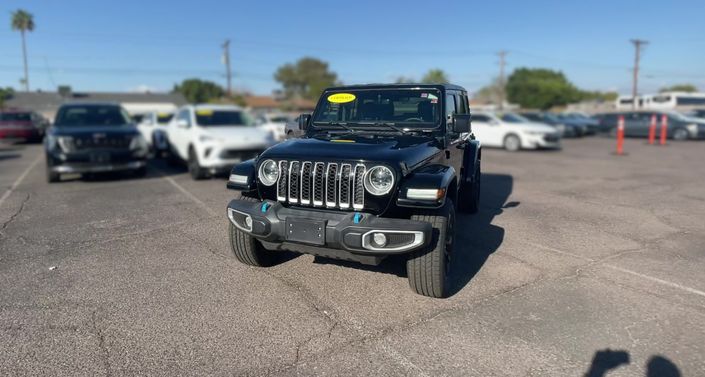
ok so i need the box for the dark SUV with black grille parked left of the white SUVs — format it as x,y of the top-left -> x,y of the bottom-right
44,103 -> 149,183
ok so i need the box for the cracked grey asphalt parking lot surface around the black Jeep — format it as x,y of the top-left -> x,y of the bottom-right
0,138 -> 705,376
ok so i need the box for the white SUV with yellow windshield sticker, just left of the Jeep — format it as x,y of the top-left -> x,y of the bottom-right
167,105 -> 274,179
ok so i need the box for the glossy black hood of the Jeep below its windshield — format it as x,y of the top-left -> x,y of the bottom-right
260,135 -> 441,169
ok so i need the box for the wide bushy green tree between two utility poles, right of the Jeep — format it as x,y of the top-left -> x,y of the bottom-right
506,68 -> 581,110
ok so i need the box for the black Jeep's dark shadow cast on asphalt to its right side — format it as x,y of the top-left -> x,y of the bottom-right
450,173 -> 520,296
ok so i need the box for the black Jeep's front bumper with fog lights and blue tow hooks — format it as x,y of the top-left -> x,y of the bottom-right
227,199 -> 432,259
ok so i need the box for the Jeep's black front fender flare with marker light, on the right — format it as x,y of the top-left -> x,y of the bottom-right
397,165 -> 456,208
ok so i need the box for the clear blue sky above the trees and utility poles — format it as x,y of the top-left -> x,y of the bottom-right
0,0 -> 705,94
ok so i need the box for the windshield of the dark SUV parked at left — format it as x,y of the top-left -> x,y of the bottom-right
54,105 -> 130,127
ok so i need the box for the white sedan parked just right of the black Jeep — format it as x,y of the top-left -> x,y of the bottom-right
472,112 -> 561,152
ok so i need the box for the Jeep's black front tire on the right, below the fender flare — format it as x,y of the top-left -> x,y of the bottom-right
406,198 -> 455,298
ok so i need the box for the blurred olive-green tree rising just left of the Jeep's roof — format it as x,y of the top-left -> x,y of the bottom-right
274,57 -> 338,101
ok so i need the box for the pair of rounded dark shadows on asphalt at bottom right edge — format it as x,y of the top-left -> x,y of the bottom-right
584,348 -> 681,377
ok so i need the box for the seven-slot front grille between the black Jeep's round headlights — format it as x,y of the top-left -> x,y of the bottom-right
277,161 -> 366,210
